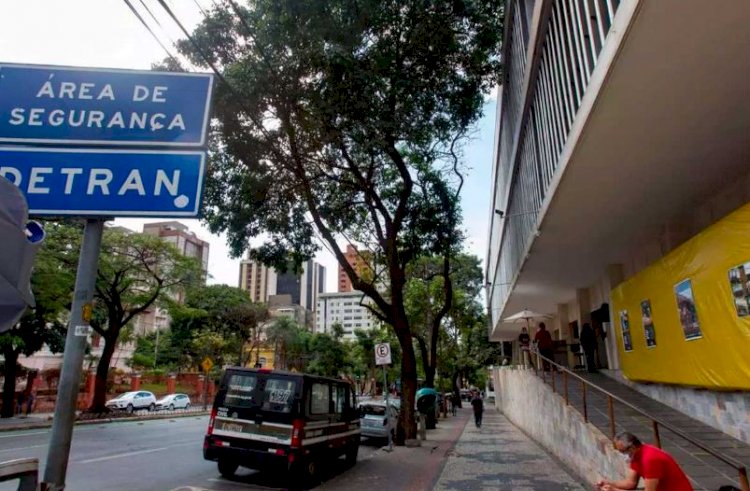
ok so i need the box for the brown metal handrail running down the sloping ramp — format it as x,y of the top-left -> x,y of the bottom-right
530,348 -> 750,491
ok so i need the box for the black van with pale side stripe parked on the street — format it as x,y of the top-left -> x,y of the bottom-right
203,368 -> 360,489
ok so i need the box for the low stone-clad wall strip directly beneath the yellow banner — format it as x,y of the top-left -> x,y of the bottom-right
602,370 -> 750,444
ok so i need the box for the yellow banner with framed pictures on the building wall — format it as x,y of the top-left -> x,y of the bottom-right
612,204 -> 750,389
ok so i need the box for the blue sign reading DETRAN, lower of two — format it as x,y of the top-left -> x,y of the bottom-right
0,147 -> 205,217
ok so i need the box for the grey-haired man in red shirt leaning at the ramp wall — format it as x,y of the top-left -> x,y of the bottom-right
596,431 -> 693,491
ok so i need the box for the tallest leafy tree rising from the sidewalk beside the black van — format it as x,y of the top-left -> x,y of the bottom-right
179,0 -> 503,442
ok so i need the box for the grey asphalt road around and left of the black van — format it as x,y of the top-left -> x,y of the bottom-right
0,416 -> 380,491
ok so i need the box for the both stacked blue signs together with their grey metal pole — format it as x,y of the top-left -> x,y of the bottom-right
27,64 -> 213,491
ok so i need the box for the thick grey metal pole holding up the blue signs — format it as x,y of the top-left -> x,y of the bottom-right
43,219 -> 104,491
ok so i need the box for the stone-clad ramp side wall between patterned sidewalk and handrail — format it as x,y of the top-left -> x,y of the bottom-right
493,367 -> 627,484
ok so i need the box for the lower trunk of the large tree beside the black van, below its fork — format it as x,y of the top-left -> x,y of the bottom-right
394,313 -> 417,445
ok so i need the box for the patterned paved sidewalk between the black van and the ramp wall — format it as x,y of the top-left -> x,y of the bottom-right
316,407 -> 585,491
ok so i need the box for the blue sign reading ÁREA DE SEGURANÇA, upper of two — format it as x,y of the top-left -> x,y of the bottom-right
0,64 -> 213,147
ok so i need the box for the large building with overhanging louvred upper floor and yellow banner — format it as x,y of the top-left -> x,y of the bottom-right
486,0 -> 750,441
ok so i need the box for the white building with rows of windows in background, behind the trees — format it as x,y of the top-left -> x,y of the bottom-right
315,290 -> 377,339
